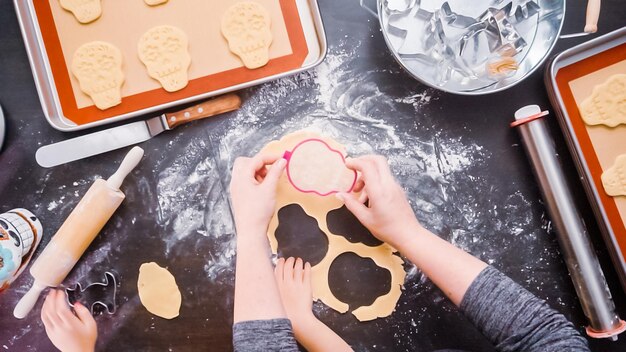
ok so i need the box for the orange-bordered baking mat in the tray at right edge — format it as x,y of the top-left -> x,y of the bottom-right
556,44 -> 626,258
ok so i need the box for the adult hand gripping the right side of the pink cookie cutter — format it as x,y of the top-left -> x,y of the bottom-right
337,155 -> 422,248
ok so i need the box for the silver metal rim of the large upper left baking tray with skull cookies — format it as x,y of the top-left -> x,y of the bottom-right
14,0 -> 327,132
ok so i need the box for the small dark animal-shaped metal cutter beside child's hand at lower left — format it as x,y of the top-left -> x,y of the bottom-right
65,271 -> 118,315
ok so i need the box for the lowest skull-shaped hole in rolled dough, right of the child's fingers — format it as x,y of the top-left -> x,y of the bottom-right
328,252 -> 391,310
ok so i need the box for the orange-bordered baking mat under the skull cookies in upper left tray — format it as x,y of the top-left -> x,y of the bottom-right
33,0 -> 308,125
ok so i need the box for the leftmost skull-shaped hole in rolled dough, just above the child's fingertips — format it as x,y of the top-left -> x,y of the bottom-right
276,204 -> 328,266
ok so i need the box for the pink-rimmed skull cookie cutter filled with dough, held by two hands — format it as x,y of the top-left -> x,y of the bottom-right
283,138 -> 358,197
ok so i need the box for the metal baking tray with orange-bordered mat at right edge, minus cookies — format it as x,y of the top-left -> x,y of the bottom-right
544,27 -> 626,292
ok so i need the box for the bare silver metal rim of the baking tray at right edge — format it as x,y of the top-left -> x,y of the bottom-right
545,27 -> 626,292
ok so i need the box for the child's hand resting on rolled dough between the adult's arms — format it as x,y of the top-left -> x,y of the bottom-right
274,258 -> 315,330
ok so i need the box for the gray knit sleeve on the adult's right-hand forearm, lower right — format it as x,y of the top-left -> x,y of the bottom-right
460,267 -> 589,352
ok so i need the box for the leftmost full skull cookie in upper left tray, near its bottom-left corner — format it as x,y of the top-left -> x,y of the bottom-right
71,41 -> 124,110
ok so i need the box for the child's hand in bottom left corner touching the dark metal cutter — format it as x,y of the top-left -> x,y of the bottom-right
41,289 -> 98,352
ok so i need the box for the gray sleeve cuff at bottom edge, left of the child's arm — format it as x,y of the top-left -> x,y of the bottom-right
233,319 -> 299,352
